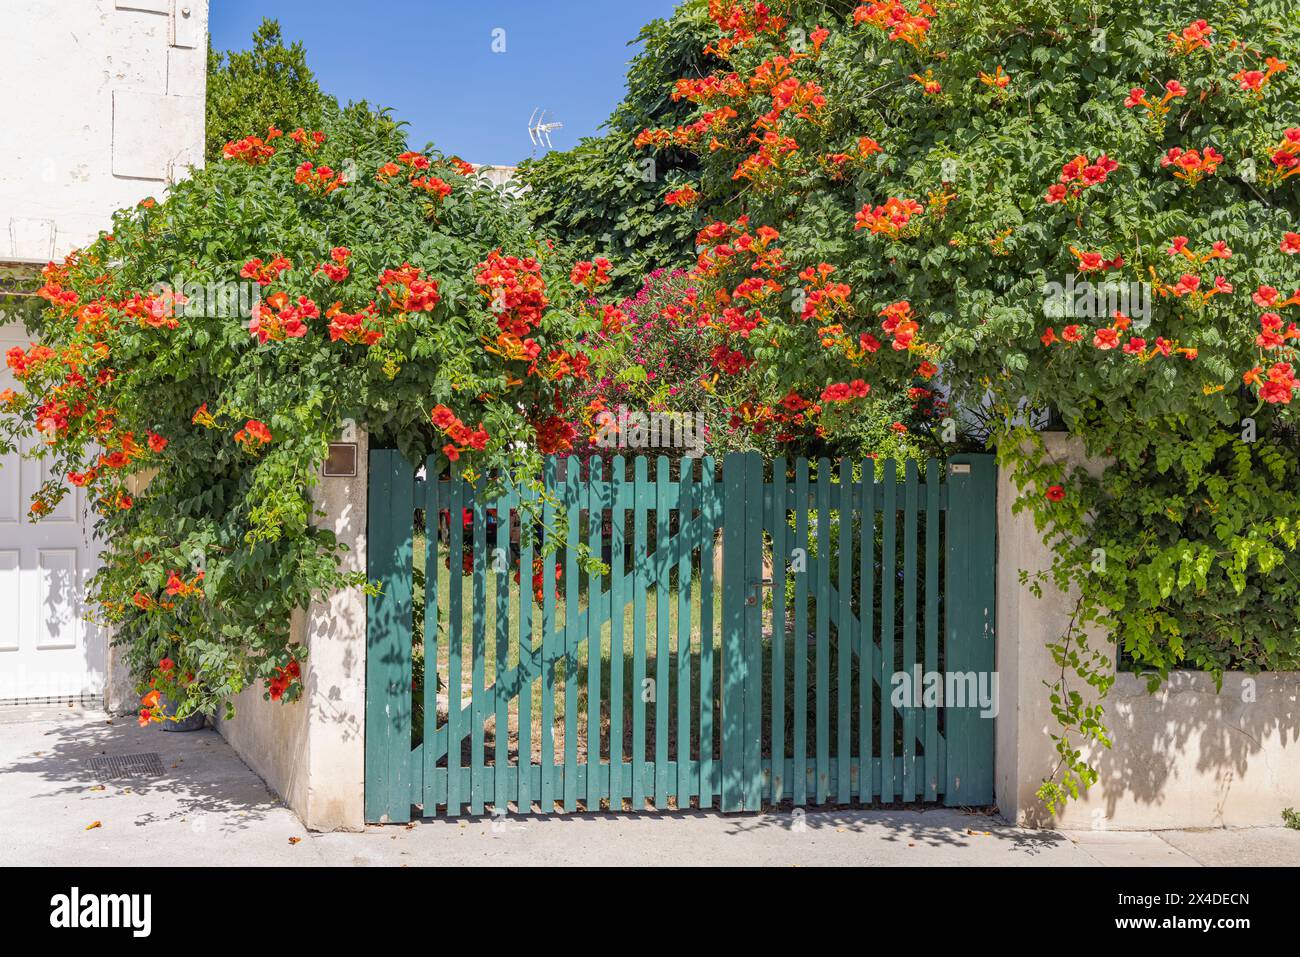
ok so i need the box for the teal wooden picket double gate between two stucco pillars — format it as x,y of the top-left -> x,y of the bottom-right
365,450 -> 996,822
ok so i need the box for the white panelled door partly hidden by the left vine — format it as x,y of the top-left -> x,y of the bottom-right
0,322 -> 105,702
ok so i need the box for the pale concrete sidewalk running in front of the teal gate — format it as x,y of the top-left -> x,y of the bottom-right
0,710 -> 1300,867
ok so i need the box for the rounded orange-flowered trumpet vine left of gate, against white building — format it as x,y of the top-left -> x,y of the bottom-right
0,108 -> 629,723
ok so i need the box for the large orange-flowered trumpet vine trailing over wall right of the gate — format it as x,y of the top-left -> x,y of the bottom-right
621,0 -> 1300,807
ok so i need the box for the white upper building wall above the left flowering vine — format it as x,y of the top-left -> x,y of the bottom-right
0,0 -> 208,263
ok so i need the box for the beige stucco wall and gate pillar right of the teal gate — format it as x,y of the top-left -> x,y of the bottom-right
996,434 -> 1300,830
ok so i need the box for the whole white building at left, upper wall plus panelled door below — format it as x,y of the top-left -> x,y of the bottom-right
0,0 -> 208,709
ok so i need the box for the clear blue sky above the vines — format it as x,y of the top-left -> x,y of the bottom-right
211,0 -> 676,165
